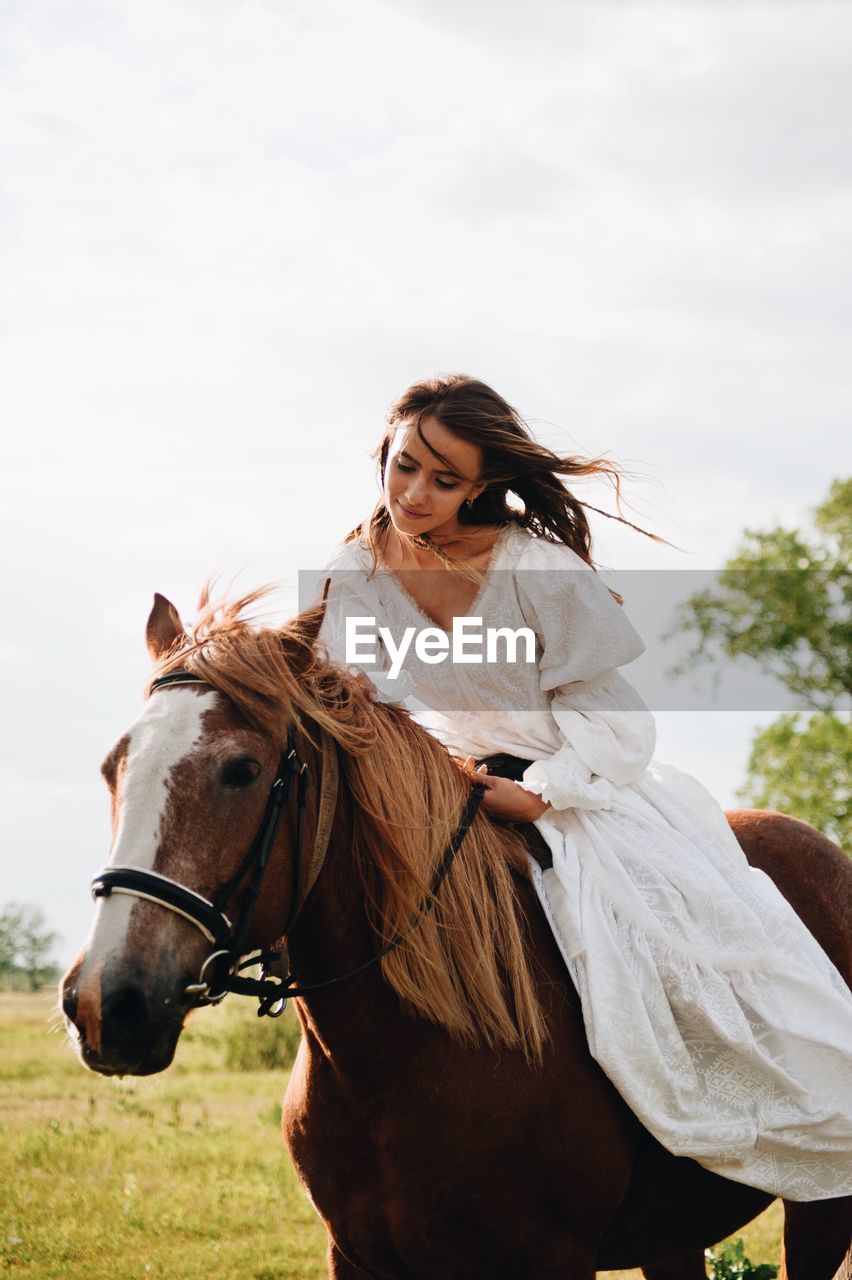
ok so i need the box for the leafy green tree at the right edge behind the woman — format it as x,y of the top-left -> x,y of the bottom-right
675,479 -> 852,847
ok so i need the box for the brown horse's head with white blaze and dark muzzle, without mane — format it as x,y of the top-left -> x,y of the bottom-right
61,595 -> 332,1075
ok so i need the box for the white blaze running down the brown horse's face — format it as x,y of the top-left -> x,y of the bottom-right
86,686 -> 216,972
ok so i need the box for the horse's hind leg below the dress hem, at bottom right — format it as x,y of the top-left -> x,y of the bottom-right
780,1196 -> 852,1280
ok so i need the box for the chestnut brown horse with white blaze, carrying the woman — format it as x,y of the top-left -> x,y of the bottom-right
63,596 -> 852,1280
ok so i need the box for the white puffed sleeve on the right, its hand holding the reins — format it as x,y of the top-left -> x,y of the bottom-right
517,539 -> 656,809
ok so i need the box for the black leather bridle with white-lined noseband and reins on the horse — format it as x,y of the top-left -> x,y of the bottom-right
92,669 -> 485,1018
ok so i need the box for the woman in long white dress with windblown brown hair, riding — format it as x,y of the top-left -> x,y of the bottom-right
313,375 -> 852,1201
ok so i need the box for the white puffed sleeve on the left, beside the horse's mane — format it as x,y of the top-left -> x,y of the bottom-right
316,543 -> 412,703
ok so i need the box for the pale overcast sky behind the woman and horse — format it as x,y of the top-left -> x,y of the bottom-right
0,0 -> 852,963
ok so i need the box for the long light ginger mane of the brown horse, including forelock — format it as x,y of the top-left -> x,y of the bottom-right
152,589 -> 546,1060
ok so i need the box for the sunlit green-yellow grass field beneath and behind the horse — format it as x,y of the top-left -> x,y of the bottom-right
0,992 -> 780,1280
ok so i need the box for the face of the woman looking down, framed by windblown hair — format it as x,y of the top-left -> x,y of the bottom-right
385,417 -> 485,538
